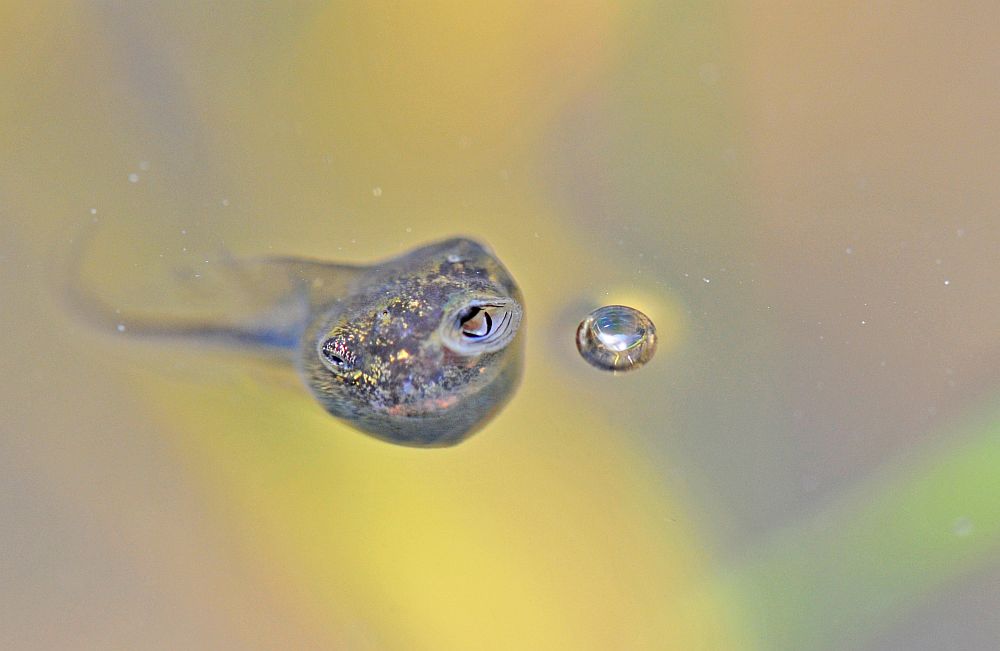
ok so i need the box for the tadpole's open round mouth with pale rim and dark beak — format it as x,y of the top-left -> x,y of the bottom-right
440,297 -> 522,355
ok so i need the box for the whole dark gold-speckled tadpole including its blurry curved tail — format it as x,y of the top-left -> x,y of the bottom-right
66,238 -> 524,447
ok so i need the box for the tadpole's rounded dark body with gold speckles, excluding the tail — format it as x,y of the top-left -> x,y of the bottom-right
297,239 -> 524,447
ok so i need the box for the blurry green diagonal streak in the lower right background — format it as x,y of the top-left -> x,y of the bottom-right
719,415 -> 1000,650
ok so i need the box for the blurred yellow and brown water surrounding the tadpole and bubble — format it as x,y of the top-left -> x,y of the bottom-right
0,3 -> 1000,649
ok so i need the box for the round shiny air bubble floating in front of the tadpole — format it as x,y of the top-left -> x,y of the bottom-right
576,305 -> 656,371
